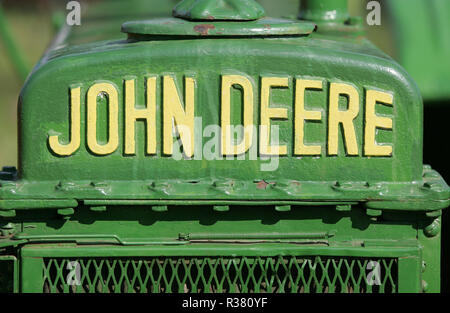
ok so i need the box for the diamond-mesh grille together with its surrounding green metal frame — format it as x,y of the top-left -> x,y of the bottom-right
19,245 -> 420,293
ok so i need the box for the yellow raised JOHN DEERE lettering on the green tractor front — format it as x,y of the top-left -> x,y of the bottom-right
48,75 -> 394,158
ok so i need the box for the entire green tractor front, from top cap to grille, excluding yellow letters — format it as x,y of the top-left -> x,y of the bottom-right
0,0 -> 450,292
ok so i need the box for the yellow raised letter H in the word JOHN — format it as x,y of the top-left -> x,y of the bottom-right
125,77 -> 156,155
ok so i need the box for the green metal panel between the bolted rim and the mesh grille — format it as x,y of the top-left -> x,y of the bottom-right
0,205 -> 439,292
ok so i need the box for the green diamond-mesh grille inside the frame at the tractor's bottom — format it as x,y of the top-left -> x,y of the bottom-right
43,256 -> 398,293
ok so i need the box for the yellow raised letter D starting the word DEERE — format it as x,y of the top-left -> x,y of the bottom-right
221,75 -> 254,155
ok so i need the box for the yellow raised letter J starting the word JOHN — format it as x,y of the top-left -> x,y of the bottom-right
48,87 -> 81,156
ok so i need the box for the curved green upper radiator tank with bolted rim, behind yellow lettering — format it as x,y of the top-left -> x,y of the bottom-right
5,23 -> 449,210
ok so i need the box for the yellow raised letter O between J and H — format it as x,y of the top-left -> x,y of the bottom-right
87,83 -> 119,155
